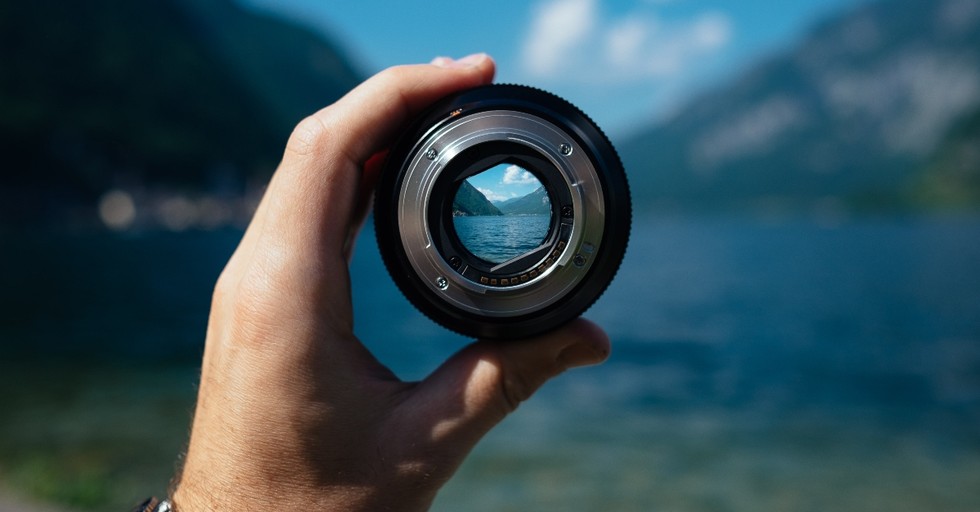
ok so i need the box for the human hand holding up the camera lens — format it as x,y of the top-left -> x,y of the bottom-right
173,55 -> 609,512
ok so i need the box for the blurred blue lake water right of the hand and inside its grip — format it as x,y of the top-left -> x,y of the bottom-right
354,218 -> 980,512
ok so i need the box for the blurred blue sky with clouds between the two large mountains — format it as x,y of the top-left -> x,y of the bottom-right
238,0 -> 868,139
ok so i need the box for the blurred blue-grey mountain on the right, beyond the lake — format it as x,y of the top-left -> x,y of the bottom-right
619,0 -> 980,210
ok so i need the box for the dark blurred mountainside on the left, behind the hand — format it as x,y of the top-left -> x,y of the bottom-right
0,0 -> 362,224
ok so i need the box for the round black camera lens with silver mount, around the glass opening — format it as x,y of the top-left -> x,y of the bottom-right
374,85 -> 631,339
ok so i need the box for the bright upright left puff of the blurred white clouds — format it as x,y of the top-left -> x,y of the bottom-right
524,0 -> 596,75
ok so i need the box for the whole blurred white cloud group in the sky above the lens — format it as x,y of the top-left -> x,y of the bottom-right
523,0 -> 733,84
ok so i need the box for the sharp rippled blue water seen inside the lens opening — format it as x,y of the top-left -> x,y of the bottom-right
453,215 -> 551,263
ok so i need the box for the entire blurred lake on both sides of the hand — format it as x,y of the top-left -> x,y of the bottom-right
0,216 -> 980,512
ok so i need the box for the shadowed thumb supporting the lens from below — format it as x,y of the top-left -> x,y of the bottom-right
417,318 -> 610,456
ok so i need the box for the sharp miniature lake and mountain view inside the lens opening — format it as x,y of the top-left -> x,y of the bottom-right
453,163 -> 551,263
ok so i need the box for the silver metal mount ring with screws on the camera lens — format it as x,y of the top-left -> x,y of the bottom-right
398,111 -> 605,317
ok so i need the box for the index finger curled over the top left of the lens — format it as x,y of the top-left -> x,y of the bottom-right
256,55 -> 494,264
